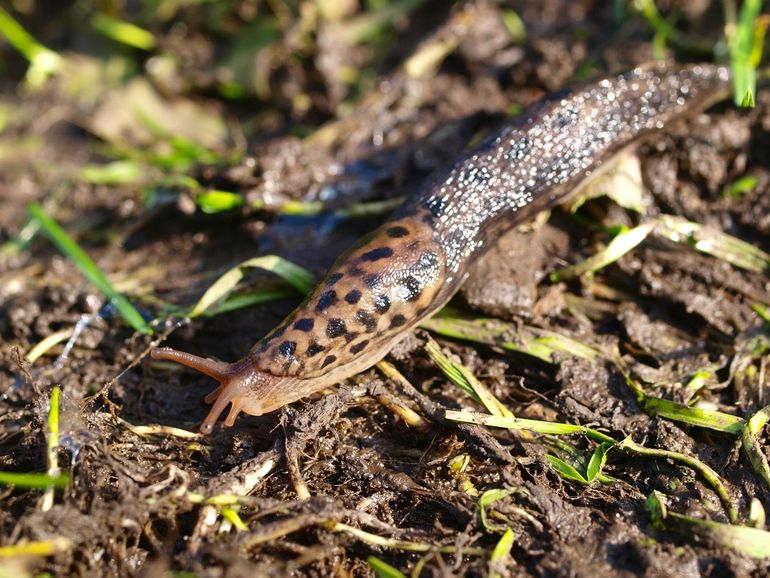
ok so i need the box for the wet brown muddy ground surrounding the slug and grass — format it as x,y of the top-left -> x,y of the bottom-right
0,0 -> 770,577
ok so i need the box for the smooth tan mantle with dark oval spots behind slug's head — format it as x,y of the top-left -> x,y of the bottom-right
249,218 -> 444,376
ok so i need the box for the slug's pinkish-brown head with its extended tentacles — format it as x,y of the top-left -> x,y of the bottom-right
150,347 -> 265,434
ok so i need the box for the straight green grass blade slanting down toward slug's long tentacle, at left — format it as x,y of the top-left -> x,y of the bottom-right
29,203 -> 152,335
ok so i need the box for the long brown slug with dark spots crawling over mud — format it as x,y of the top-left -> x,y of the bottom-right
152,63 -> 730,434
